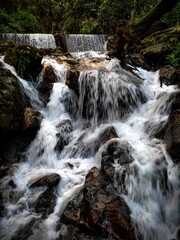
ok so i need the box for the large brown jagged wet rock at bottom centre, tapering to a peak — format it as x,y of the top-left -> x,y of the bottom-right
59,168 -> 135,240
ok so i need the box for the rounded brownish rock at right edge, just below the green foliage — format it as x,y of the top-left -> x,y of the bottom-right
159,65 -> 180,85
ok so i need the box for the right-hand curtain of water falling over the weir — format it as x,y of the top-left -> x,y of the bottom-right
65,34 -> 106,52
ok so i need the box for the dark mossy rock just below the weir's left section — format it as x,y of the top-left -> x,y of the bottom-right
4,45 -> 44,79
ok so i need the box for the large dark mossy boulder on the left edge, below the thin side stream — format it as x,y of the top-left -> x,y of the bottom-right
0,68 -> 24,131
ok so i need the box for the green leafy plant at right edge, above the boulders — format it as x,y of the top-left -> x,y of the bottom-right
166,37 -> 180,68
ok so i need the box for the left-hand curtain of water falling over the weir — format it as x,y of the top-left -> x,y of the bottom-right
0,33 -> 56,48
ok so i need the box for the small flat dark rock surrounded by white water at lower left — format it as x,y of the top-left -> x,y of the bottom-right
27,173 -> 61,188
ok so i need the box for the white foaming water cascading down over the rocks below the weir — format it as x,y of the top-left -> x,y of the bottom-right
0,51 -> 180,240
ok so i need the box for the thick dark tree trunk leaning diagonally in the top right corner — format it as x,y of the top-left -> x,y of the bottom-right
134,0 -> 178,37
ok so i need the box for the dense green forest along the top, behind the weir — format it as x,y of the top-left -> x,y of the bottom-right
0,0 -> 180,34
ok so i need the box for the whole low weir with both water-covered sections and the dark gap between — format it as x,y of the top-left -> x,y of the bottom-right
0,33 -> 107,52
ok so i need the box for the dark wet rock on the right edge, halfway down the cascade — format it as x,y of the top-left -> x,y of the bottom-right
164,109 -> 180,162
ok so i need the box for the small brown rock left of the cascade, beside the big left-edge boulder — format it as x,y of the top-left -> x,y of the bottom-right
23,107 -> 43,130
